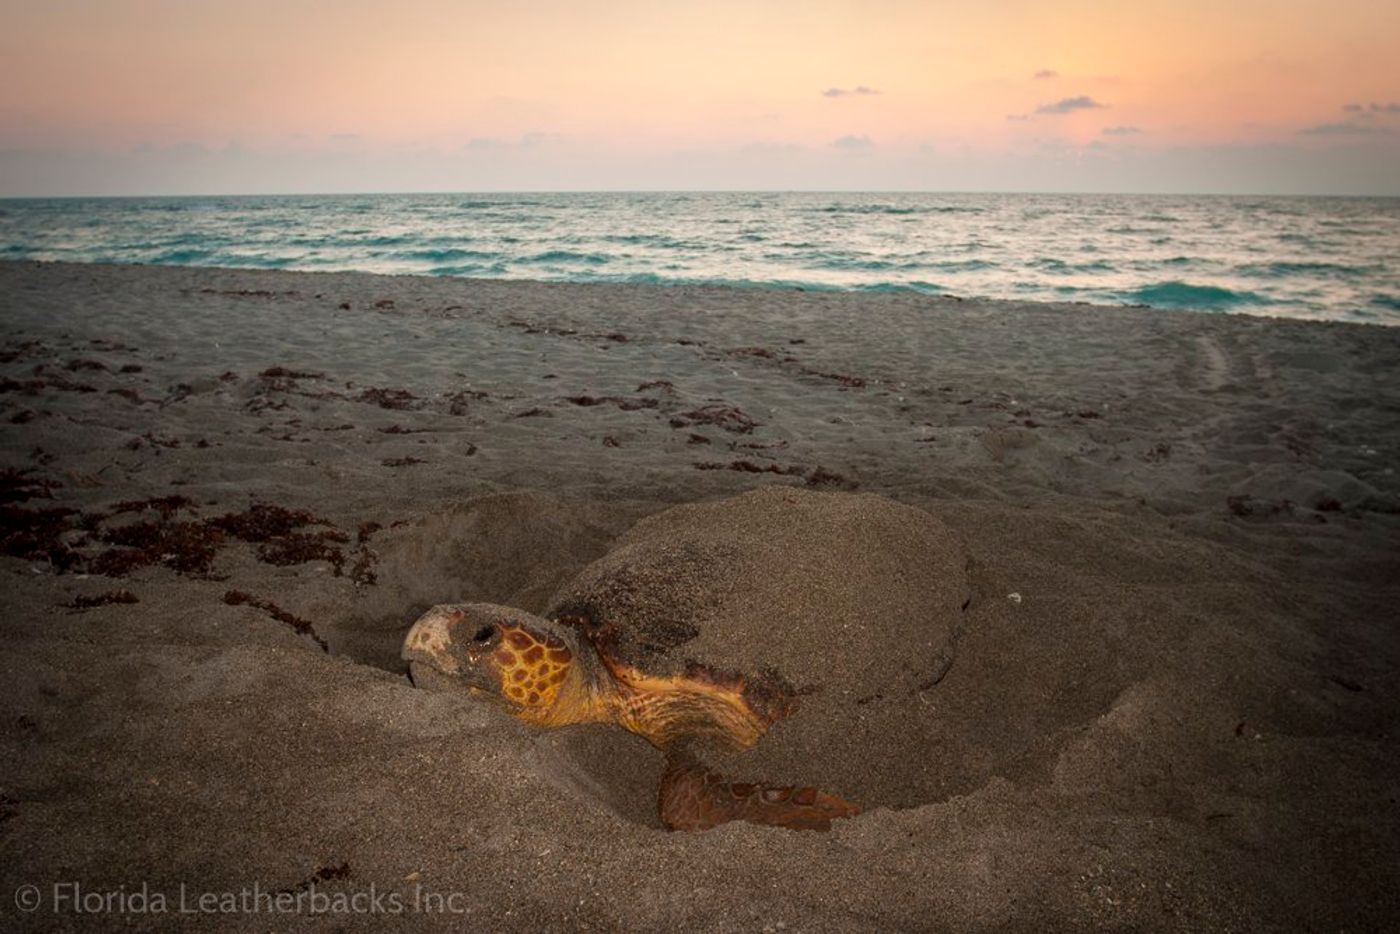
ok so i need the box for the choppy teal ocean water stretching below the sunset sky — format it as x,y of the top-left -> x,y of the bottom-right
0,192 -> 1400,325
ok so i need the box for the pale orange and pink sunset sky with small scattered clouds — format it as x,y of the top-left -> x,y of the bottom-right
0,0 -> 1400,196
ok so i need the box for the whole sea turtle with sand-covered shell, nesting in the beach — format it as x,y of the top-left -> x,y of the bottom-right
402,487 -> 966,830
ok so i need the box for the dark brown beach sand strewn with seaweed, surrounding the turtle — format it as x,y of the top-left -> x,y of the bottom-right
0,263 -> 1400,930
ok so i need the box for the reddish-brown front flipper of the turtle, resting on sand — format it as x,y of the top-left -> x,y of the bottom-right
657,752 -> 861,830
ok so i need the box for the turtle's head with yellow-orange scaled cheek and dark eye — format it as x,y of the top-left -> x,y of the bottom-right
402,604 -> 598,727
